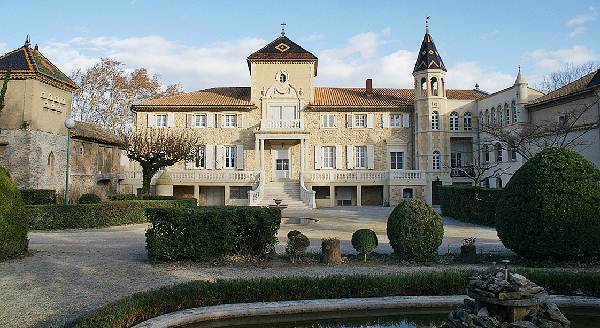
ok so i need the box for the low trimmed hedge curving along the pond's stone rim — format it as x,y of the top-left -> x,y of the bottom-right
63,269 -> 600,328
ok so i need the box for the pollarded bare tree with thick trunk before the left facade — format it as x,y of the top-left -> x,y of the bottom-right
124,129 -> 199,195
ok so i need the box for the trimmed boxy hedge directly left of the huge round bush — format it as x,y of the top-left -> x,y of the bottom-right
439,186 -> 503,227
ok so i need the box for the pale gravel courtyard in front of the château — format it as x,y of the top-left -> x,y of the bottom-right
0,207 -> 504,327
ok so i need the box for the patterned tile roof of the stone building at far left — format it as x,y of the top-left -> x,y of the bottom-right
0,45 -> 78,89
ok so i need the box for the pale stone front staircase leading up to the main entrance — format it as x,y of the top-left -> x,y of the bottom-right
257,180 -> 311,211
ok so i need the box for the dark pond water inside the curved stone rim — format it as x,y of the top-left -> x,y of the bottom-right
187,308 -> 600,328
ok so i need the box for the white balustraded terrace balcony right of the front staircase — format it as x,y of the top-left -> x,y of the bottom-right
304,170 -> 426,185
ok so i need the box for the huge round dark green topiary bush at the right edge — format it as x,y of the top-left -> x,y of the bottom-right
496,148 -> 600,259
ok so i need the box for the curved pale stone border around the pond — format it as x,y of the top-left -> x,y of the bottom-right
133,295 -> 600,328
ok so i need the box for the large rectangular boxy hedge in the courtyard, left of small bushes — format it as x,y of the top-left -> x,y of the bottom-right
146,206 -> 281,261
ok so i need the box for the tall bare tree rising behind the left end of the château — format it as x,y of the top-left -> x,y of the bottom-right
71,58 -> 181,134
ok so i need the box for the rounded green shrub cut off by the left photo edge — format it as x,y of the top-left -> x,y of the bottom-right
0,166 -> 29,261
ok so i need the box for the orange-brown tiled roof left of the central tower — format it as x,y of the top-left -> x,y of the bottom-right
133,87 -> 252,109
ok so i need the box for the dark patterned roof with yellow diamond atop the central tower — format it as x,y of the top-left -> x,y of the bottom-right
248,35 -> 317,61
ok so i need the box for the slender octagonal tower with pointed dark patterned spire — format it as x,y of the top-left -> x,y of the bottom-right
413,17 -> 451,203
